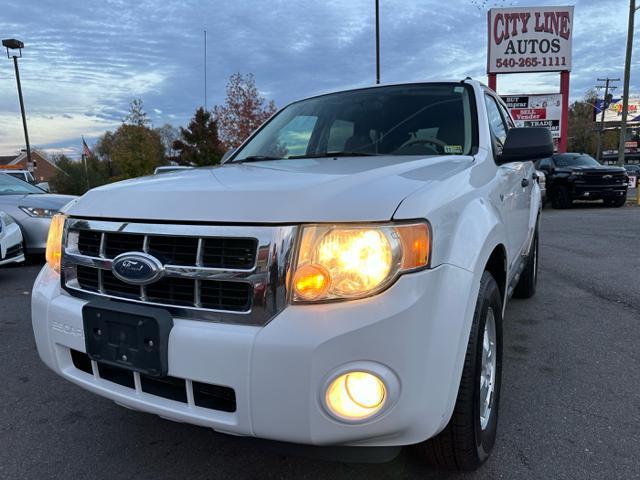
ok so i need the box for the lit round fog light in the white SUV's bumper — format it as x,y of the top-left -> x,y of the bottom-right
326,372 -> 387,420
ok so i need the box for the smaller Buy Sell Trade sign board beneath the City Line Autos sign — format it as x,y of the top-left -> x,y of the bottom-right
502,93 -> 562,138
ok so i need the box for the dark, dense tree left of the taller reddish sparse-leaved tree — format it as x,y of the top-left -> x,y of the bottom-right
173,107 -> 224,166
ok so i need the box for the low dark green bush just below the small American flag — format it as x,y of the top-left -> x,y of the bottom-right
51,155 -> 109,195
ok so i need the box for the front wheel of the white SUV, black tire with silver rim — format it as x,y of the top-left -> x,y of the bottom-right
415,271 -> 502,471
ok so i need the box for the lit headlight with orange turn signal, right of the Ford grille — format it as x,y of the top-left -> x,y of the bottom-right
291,223 -> 431,302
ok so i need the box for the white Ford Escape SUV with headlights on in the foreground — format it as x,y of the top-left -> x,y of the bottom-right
32,80 -> 553,469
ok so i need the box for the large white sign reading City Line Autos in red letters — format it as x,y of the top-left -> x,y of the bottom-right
487,7 -> 573,73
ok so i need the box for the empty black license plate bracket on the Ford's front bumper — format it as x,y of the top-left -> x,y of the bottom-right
82,300 -> 173,377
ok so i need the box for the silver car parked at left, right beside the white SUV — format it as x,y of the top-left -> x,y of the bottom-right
0,173 -> 76,255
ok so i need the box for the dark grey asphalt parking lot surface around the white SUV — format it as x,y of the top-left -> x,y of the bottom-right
0,206 -> 640,479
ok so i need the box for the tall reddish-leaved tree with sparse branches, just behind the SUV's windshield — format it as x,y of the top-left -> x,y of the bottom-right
214,73 -> 276,149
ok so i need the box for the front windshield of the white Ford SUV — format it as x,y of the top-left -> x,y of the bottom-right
233,83 -> 477,161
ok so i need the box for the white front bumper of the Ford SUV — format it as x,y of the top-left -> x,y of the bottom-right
32,265 -> 477,446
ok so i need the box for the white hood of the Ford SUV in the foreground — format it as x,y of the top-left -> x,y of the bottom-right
67,156 -> 473,223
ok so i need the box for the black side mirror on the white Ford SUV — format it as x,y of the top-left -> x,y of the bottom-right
498,127 -> 553,164
